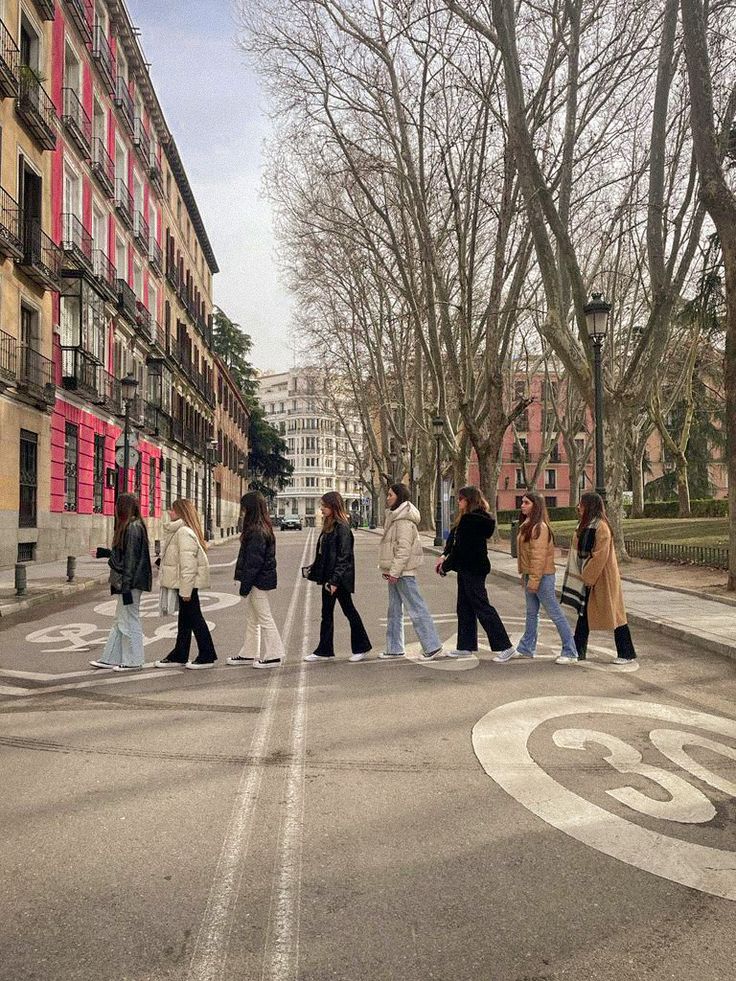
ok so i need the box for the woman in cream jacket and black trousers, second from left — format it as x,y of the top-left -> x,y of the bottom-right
155,498 -> 217,669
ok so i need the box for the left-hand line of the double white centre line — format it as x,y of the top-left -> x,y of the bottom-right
187,532 -> 312,981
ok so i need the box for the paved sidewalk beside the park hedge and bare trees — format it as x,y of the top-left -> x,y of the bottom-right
376,529 -> 736,659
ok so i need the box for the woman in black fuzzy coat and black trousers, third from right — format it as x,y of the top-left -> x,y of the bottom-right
436,487 -> 515,659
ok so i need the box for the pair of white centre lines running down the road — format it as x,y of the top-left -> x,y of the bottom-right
187,531 -> 314,981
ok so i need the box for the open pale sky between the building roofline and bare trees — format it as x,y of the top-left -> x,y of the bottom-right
127,0 -> 292,370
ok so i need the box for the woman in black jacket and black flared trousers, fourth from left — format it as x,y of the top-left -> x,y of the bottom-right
304,491 -> 371,661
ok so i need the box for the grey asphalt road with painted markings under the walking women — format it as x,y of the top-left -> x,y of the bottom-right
0,531 -> 736,981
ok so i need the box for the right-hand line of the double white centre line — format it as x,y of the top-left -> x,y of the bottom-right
261,568 -> 313,981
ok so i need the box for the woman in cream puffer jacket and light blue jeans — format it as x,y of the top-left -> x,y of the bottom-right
378,484 -> 442,660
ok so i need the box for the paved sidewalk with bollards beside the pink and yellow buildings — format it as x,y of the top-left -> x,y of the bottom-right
0,538 -> 235,622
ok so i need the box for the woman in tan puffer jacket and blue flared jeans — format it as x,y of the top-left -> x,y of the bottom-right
493,491 -> 578,664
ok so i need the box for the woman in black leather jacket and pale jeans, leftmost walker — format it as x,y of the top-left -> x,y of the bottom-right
90,494 -> 152,671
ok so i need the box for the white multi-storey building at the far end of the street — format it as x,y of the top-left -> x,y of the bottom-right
258,370 -> 366,527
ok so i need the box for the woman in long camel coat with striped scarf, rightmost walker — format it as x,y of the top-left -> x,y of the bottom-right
557,491 -> 636,664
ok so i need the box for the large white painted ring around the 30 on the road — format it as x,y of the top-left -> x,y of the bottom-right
472,695 -> 736,900
